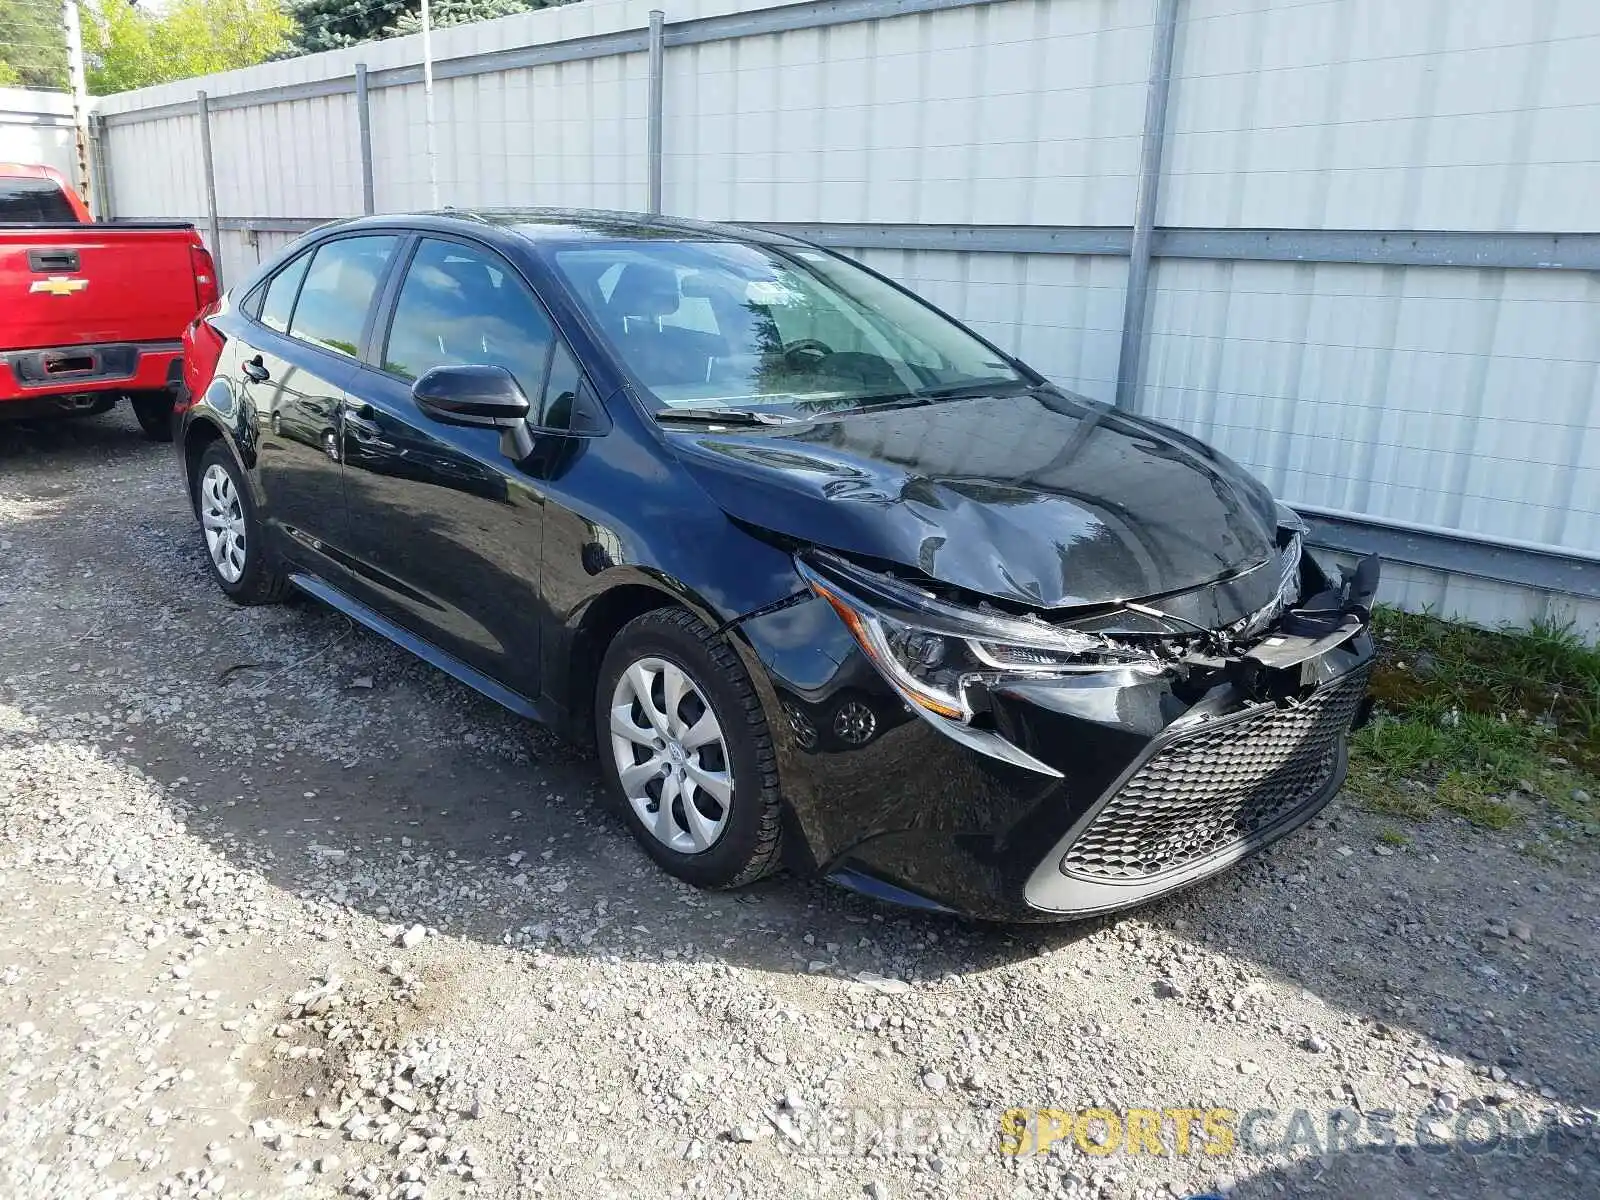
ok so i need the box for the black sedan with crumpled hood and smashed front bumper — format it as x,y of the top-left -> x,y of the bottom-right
174,211 -> 1378,920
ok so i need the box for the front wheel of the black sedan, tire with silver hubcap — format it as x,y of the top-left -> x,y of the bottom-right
594,608 -> 781,888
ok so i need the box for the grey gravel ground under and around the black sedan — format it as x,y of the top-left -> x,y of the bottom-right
0,413 -> 1600,1200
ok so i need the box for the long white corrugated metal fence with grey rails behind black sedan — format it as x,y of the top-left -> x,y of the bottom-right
84,0 -> 1600,637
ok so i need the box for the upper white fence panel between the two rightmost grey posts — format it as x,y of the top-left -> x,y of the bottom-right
664,0 -> 1150,224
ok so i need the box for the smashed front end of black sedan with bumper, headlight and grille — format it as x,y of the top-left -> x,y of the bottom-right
755,510 -> 1378,918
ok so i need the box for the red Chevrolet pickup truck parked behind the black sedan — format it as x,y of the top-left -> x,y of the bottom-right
0,163 -> 218,442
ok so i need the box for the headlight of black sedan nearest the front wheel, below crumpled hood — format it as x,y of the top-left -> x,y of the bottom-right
795,554 -> 1166,723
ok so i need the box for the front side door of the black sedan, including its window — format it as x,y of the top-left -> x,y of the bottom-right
341,237 -> 554,701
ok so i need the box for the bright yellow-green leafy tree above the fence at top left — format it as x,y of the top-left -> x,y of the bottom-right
83,0 -> 294,96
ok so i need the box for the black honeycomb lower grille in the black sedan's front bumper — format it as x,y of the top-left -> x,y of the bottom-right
1061,670 -> 1366,880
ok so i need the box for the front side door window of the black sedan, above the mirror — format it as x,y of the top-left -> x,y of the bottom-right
384,238 -> 554,400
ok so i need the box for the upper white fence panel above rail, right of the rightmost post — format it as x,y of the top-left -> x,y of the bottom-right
1157,0 -> 1600,232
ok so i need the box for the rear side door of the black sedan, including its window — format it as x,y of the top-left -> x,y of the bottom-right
232,234 -> 400,576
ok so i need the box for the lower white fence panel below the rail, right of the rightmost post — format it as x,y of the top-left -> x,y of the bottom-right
1141,259 -> 1600,550
